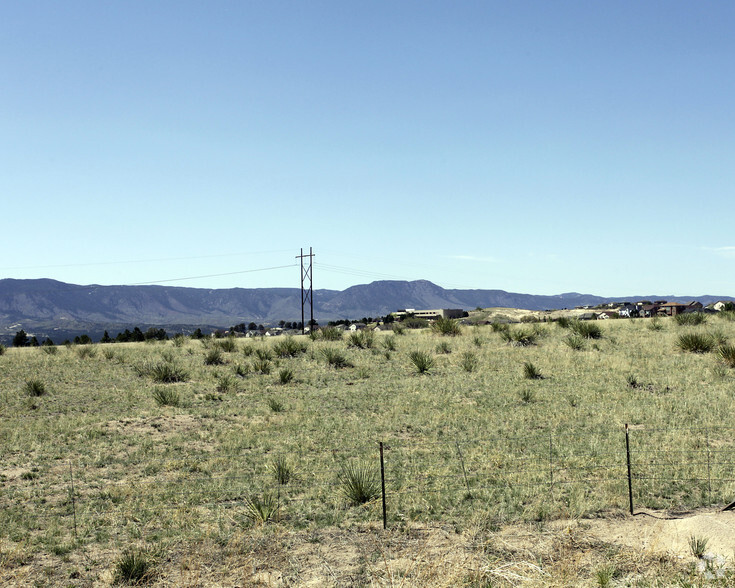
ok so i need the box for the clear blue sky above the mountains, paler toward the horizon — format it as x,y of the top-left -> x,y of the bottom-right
0,0 -> 735,296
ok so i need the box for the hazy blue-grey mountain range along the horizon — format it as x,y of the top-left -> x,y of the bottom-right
0,279 -> 733,343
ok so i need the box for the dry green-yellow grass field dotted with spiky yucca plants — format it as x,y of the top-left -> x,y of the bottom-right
0,309 -> 735,587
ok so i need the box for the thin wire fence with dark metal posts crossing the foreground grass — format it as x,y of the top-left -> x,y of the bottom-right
0,425 -> 735,539
